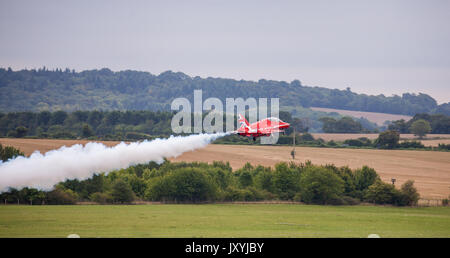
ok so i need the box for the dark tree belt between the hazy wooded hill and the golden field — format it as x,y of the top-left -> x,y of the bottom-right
0,111 -> 450,150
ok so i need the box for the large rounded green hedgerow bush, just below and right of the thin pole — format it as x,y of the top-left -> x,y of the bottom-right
300,167 -> 344,204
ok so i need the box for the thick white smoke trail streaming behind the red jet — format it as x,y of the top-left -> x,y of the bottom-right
0,133 -> 227,193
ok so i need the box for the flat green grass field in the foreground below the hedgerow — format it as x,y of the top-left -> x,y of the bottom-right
0,204 -> 450,238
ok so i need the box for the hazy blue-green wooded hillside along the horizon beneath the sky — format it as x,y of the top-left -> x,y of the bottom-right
0,67 -> 450,115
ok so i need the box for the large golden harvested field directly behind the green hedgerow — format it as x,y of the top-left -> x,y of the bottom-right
0,138 -> 450,199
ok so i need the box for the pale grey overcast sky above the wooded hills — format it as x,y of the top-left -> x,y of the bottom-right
0,0 -> 450,103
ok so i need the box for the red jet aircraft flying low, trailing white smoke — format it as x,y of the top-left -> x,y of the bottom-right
236,114 -> 290,141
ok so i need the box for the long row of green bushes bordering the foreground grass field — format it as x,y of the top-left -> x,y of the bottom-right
0,158 -> 420,206
